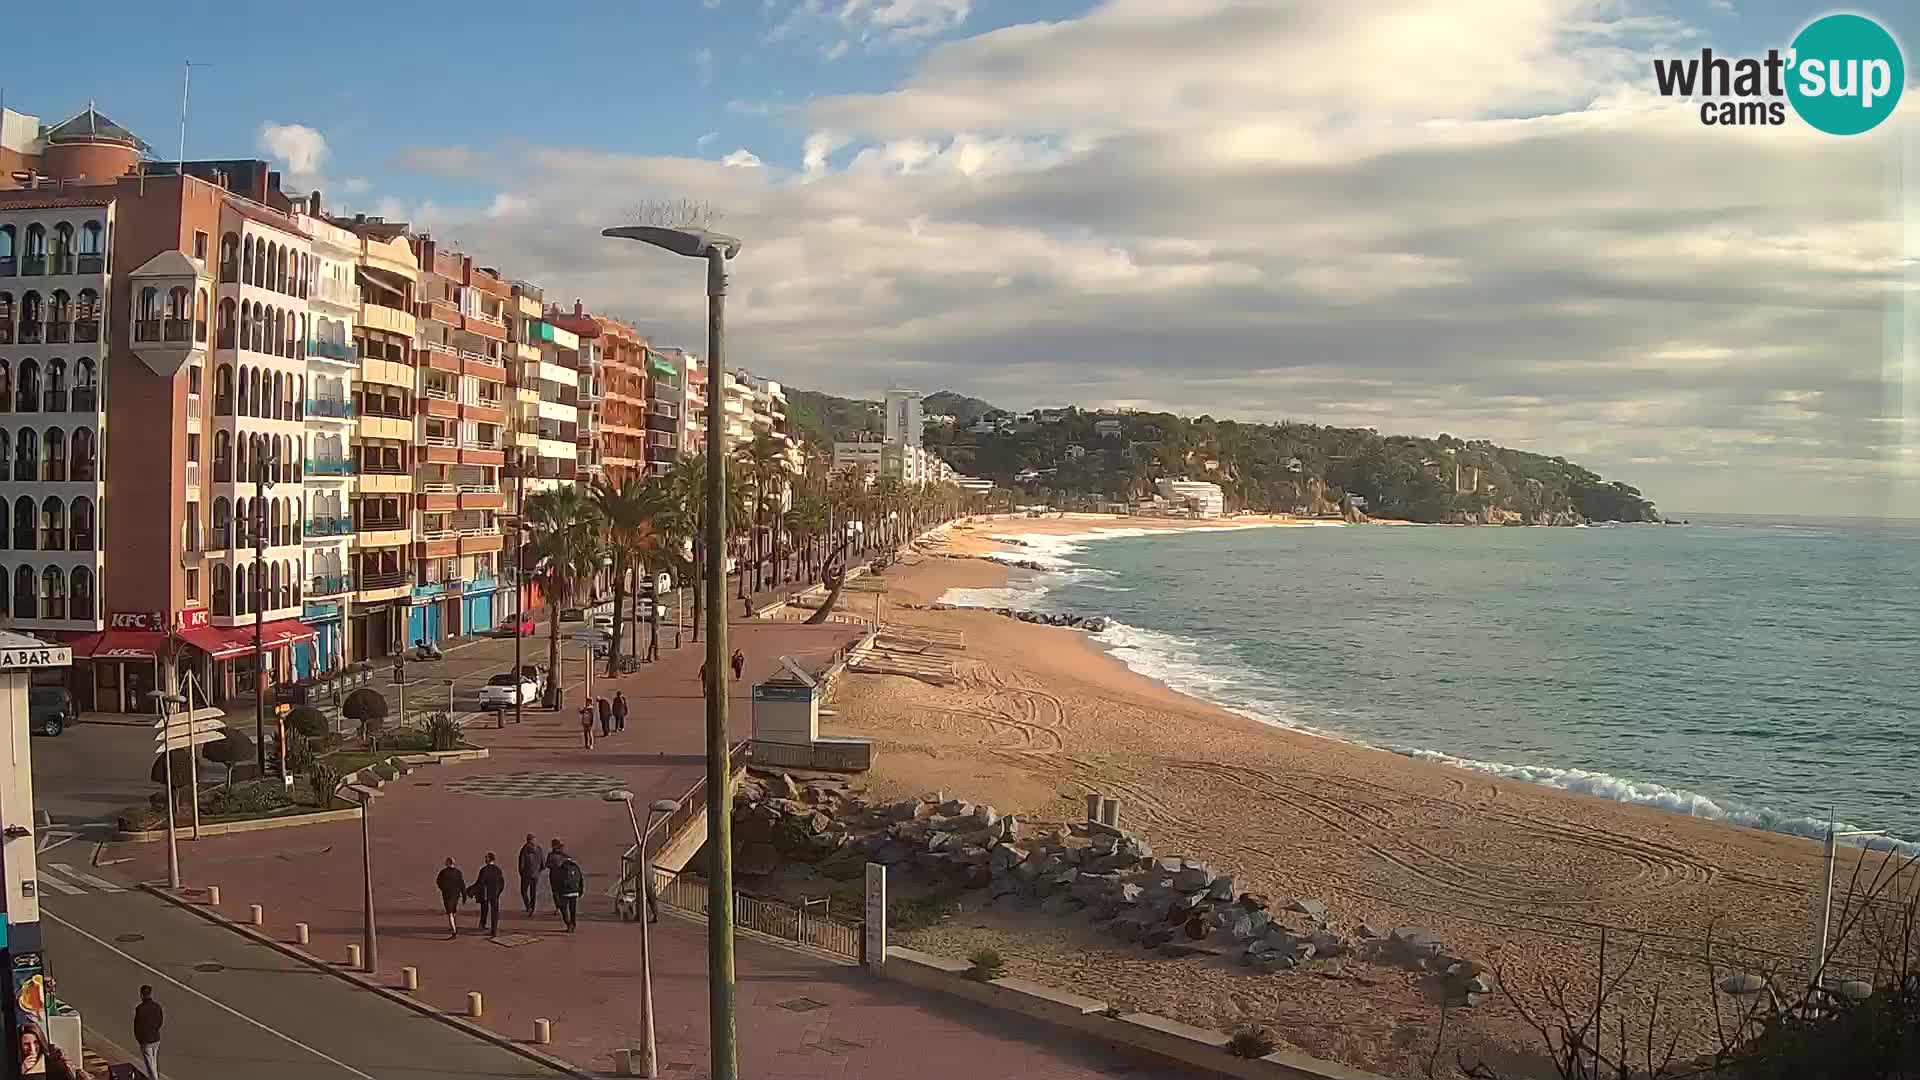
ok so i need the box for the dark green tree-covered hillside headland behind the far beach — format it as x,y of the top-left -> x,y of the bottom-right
787,392 -> 1659,525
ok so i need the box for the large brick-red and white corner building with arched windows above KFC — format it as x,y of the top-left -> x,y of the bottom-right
0,108 -> 341,711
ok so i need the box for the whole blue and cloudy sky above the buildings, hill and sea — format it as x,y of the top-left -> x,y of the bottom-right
0,0 -> 1920,515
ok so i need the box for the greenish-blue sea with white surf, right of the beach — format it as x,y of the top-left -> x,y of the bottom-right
943,517 -> 1920,853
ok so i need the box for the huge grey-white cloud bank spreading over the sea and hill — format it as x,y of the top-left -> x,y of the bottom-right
382,0 -> 1920,515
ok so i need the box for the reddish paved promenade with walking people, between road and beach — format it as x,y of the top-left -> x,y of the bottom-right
119,623 -> 1169,1080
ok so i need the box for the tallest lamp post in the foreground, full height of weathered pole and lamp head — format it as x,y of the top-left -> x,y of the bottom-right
601,225 -> 739,1080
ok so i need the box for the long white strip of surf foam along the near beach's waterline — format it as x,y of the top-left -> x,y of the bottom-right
1092,621 -> 1920,855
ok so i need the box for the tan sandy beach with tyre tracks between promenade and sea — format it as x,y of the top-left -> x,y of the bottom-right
822,515 -> 1881,1076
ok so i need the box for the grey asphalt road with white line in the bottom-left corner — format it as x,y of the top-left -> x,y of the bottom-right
40,883 -> 559,1080
